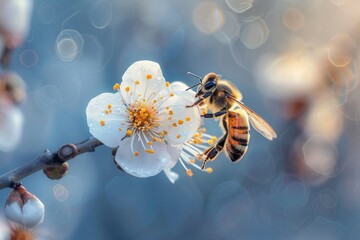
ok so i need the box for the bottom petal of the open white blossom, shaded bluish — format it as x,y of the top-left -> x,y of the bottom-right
115,133 -> 170,177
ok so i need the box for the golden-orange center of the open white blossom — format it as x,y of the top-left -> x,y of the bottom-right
128,105 -> 155,132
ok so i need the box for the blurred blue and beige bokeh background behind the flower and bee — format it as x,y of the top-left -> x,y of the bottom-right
0,0 -> 360,240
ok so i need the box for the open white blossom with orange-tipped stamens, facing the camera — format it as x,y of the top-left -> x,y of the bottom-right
86,61 -> 201,177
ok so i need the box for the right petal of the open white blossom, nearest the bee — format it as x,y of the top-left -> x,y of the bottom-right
160,91 -> 202,144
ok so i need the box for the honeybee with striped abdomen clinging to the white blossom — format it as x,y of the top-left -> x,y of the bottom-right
187,72 -> 277,169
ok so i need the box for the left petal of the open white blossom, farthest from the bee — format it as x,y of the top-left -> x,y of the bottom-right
86,93 -> 128,147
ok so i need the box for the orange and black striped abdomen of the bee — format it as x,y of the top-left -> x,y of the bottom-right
225,109 -> 250,162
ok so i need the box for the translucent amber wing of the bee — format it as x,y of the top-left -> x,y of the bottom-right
228,96 -> 277,140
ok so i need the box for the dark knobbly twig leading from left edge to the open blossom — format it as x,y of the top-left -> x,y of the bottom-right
0,137 -> 103,189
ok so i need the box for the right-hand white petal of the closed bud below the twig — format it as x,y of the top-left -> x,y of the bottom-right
22,199 -> 45,228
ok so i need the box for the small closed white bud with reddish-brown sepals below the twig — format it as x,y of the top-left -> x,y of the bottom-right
5,186 -> 45,228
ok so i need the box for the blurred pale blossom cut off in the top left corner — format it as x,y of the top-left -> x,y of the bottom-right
0,0 -> 33,48
